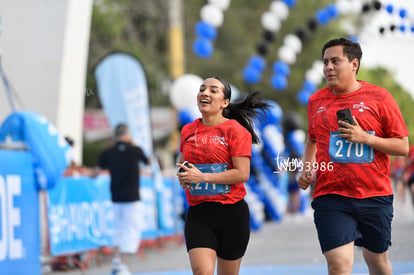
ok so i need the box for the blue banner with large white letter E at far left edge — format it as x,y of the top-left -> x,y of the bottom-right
0,150 -> 41,275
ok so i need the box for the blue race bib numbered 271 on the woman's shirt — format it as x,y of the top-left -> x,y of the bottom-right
190,163 -> 230,196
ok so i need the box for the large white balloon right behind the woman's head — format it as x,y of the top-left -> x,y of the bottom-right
170,74 -> 203,110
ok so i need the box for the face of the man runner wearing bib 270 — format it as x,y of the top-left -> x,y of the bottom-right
323,46 -> 358,94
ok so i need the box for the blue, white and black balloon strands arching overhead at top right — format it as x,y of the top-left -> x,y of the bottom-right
189,0 -> 414,105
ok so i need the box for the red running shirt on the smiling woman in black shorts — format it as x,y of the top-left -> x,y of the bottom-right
180,119 -> 252,205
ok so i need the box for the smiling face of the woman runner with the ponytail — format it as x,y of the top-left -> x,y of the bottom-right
197,78 -> 230,114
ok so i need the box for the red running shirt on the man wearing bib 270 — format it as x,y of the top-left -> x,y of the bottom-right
308,81 -> 408,199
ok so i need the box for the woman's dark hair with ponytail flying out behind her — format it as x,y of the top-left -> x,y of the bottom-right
211,76 -> 271,144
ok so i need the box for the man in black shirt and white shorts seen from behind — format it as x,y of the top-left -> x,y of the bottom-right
98,123 -> 149,274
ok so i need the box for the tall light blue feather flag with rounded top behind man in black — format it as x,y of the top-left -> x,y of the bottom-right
95,53 -> 153,156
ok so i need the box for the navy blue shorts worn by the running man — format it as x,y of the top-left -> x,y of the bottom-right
312,195 -> 394,253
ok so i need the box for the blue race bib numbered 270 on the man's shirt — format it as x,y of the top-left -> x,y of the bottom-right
329,131 -> 375,163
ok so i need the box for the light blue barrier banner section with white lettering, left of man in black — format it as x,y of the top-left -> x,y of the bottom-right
48,176 -> 113,256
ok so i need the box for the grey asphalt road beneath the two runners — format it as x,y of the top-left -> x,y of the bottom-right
44,197 -> 414,275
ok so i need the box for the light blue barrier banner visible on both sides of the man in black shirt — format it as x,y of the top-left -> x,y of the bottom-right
48,175 -> 181,256
